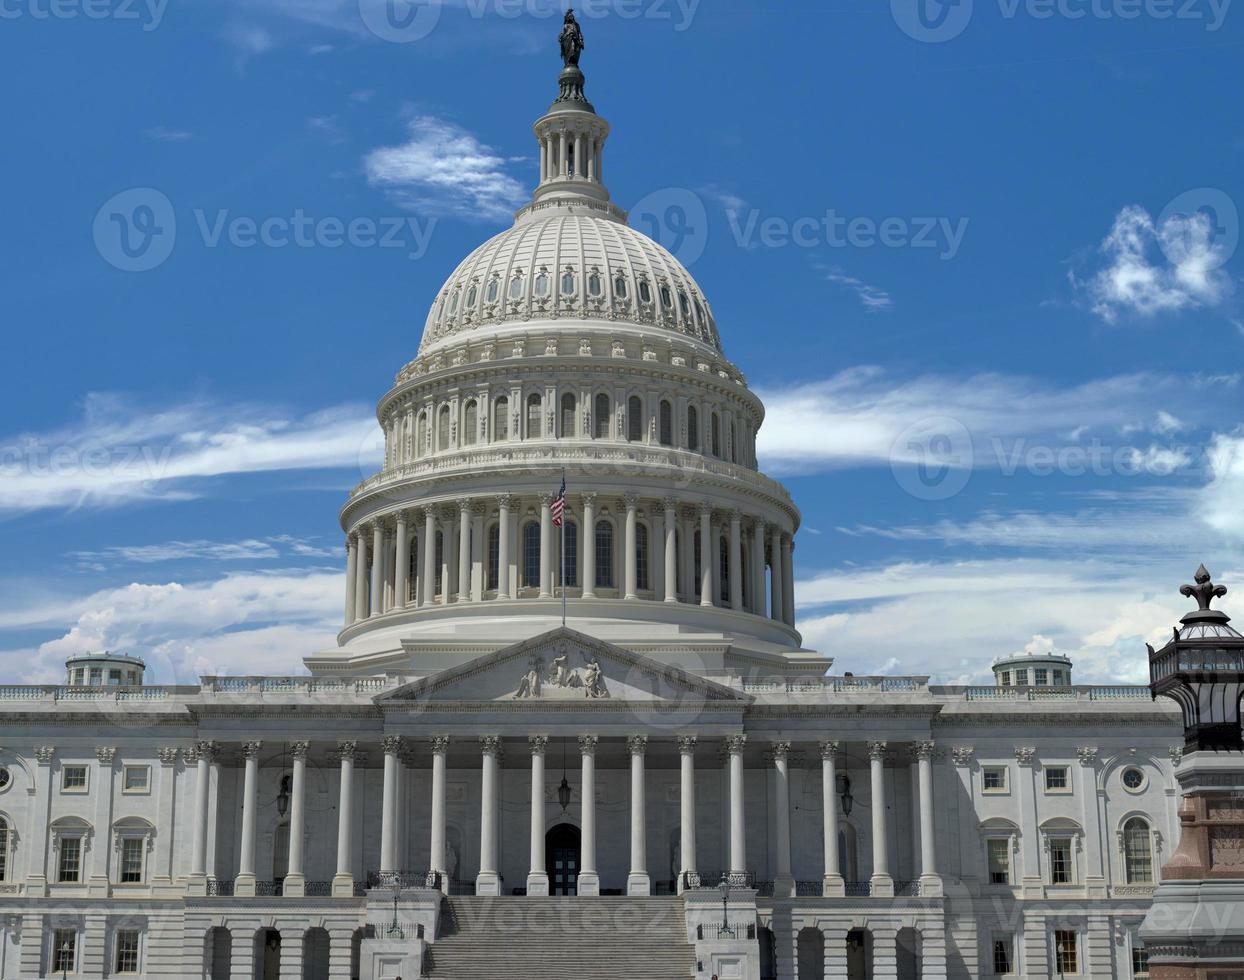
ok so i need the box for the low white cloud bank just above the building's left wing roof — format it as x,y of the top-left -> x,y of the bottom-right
0,570 -> 345,684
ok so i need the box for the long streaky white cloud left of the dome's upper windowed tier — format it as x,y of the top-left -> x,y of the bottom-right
0,394 -> 382,515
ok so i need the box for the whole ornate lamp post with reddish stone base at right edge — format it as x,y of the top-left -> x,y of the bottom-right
1141,565 -> 1244,980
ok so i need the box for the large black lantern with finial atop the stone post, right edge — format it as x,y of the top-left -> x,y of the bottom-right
1148,565 -> 1244,752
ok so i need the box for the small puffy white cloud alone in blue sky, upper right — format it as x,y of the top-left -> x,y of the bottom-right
1072,204 -> 1232,323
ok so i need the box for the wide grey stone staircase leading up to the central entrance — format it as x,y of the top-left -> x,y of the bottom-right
424,897 -> 695,980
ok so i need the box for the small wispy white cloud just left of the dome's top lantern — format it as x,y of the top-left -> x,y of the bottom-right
363,116 -> 527,220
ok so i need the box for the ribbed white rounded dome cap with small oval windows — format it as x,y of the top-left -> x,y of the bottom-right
419,198 -> 722,354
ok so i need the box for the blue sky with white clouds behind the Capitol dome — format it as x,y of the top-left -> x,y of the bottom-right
0,0 -> 1244,683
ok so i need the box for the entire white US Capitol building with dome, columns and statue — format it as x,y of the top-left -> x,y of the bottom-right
0,16 -> 1183,980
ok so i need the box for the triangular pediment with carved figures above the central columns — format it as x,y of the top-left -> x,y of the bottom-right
376,627 -> 751,705
